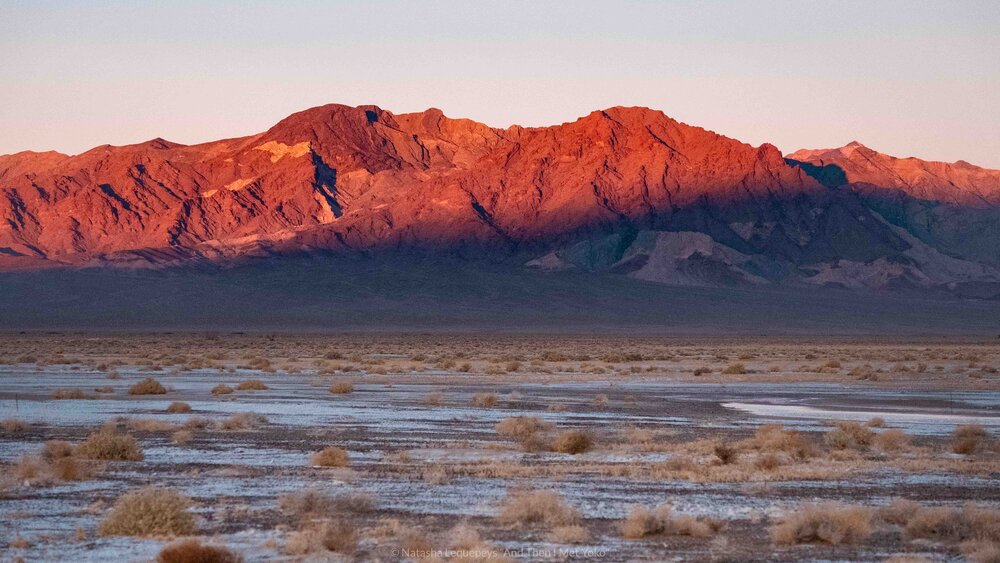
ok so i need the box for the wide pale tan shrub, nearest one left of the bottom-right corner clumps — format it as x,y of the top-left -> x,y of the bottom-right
771,502 -> 873,545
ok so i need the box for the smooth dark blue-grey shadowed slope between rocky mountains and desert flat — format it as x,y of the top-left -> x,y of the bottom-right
0,256 -> 1000,336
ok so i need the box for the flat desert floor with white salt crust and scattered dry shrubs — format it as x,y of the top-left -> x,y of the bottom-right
0,333 -> 1000,563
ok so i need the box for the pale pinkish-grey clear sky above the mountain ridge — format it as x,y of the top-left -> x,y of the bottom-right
0,0 -> 1000,168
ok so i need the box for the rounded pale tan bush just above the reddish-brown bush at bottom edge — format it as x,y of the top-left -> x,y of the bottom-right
97,486 -> 195,537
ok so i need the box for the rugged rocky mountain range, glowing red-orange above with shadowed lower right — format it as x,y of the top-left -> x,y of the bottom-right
0,105 -> 1000,297
